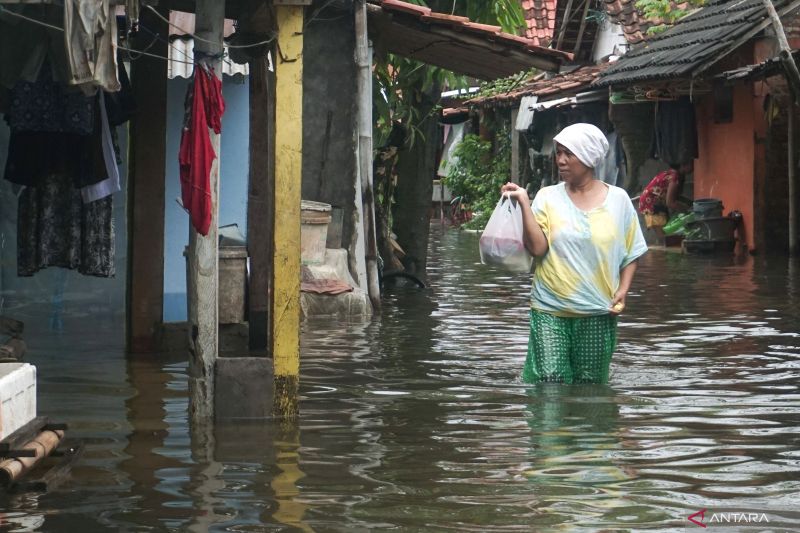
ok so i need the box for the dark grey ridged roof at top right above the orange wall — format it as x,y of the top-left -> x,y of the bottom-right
594,0 -> 800,87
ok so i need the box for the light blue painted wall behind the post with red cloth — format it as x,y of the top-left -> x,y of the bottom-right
164,77 -> 250,322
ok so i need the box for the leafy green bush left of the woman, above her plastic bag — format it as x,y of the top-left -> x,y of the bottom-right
444,127 -> 511,228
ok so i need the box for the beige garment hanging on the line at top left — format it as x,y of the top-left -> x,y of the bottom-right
64,0 -> 120,94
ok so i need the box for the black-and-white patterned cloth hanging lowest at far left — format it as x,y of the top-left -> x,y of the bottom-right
17,174 -> 114,278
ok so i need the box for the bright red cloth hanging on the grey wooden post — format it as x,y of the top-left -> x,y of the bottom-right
178,65 -> 225,235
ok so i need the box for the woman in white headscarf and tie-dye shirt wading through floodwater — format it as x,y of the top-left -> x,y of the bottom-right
502,124 -> 647,383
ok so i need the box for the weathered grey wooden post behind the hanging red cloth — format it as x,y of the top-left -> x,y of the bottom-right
187,0 -> 225,424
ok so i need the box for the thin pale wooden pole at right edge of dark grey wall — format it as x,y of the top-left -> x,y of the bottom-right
354,0 -> 381,313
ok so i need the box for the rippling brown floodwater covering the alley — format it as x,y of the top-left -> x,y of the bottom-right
0,226 -> 800,532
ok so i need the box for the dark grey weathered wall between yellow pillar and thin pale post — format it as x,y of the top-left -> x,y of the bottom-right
304,8 -> 361,272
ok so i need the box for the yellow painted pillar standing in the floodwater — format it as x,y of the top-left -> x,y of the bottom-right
272,6 -> 304,419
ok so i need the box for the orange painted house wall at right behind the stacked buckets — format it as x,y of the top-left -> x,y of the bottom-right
694,84 -> 756,251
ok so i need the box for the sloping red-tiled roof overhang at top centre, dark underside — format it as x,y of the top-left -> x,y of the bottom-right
367,0 -> 572,79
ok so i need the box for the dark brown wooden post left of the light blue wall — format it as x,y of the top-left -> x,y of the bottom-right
126,9 -> 168,353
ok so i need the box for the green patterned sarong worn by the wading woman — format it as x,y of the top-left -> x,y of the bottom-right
522,309 -> 617,383
